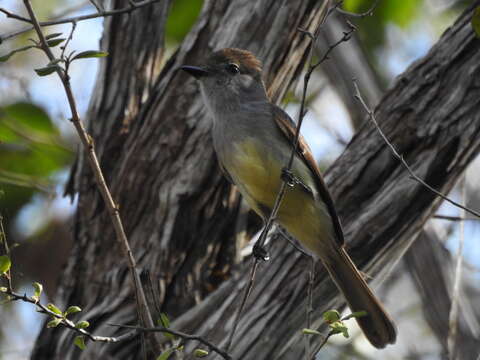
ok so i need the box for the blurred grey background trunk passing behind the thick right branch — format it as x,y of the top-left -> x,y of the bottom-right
317,14 -> 480,359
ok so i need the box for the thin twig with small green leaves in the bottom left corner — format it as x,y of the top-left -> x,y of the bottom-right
2,289 -> 138,343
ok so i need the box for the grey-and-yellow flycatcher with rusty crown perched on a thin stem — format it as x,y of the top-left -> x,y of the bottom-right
182,49 -> 397,348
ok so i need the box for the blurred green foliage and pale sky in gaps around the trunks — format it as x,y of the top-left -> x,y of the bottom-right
0,0 -> 480,359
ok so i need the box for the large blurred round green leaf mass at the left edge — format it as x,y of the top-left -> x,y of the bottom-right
0,102 -> 73,208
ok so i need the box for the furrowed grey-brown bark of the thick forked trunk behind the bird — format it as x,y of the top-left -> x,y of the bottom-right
32,0 -> 480,359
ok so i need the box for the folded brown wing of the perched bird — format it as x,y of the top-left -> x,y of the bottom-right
272,105 -> 345,245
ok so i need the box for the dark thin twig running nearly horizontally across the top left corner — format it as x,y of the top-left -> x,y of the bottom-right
0,0 -> 160,43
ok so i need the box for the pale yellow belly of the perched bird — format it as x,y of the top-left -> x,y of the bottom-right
224,140 -> 334,256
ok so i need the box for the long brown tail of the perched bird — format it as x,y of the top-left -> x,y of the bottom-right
323,248 -> 397,349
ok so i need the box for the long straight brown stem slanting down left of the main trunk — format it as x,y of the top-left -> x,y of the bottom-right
23,0 -> 158,346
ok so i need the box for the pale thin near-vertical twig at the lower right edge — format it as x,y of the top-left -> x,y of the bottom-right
447,174 -> 467,359
